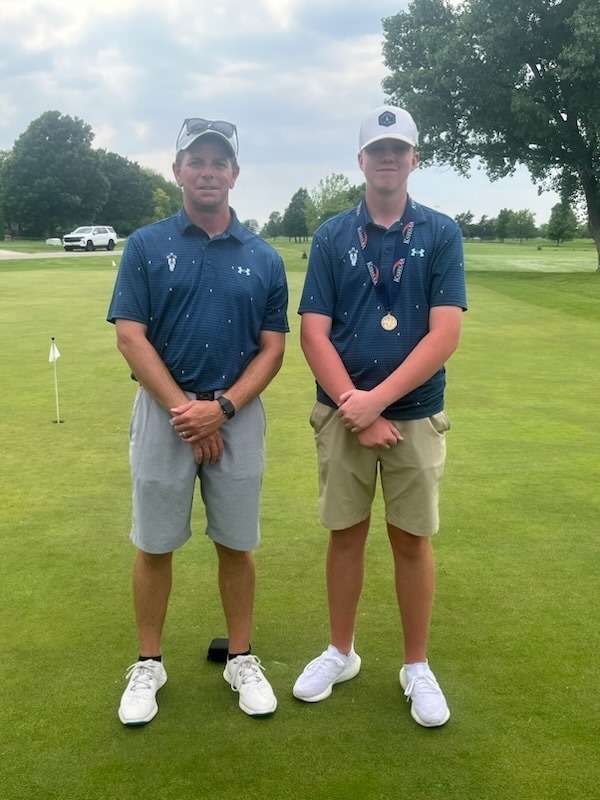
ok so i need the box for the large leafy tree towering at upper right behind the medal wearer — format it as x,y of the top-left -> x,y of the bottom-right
383,0 -> 600,269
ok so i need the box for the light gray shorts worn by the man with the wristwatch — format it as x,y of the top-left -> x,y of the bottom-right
129,387 -> 265,553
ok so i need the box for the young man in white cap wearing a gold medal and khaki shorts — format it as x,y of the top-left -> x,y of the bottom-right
294,106 -> 466,727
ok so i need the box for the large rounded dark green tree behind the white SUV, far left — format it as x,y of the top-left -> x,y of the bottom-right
4,111 -> 110,237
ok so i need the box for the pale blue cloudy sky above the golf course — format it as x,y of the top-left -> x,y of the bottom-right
0,0 -> 556,224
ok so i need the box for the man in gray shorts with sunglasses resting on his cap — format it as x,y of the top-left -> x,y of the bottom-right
108,119 -> 288,725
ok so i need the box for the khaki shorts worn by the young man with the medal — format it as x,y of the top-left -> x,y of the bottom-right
310,402 -> 450,536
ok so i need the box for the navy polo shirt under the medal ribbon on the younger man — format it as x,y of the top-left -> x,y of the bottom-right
298,198 -> 467,419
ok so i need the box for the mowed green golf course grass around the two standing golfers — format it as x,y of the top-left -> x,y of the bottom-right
0,242 -> 600,800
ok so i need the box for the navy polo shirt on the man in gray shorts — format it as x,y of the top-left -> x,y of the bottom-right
107,209 -> 289,392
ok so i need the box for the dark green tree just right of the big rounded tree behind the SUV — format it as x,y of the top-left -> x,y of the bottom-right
94,150 -> 154,236
